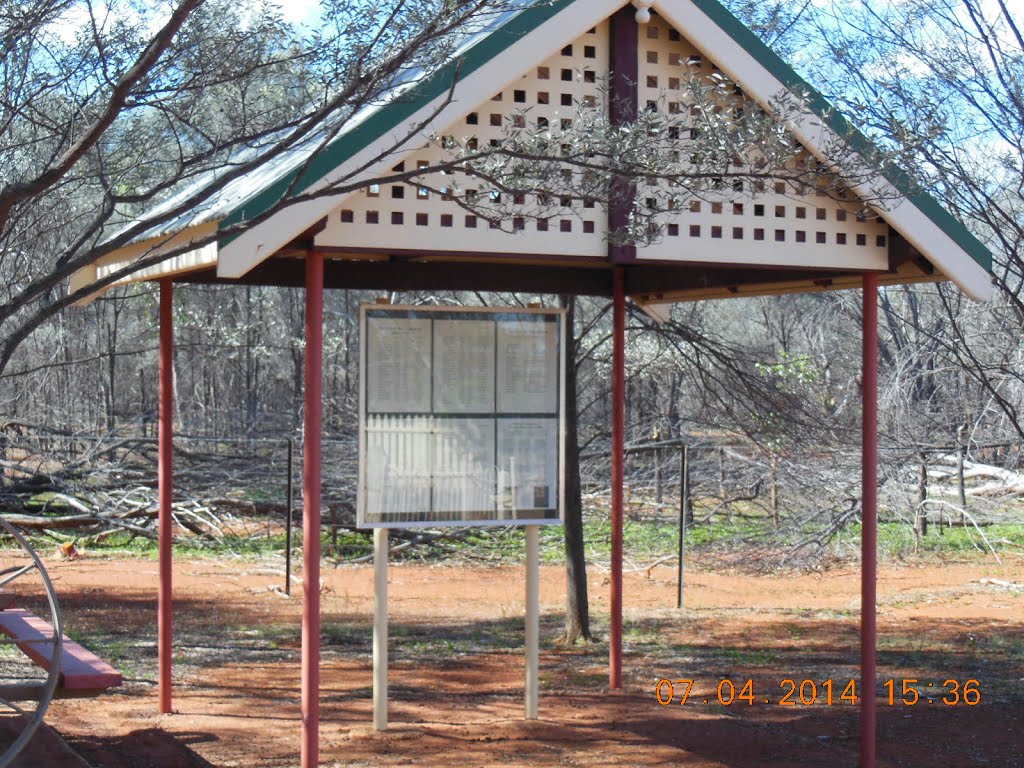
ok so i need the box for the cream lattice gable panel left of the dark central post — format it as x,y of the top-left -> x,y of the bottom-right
316,23 -> 609,257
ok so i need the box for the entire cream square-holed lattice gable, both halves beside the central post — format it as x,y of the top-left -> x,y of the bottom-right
316,14 -> 890,269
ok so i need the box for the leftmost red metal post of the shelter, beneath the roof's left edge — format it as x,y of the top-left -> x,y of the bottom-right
157,278 -> 174,714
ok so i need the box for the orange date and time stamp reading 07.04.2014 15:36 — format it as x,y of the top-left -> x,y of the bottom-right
654,678 -> 981,707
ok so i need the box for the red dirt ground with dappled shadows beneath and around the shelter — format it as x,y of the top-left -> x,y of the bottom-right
2,555 -> 1024,768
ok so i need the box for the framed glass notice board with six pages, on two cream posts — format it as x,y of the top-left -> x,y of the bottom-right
356,304 -> 568,528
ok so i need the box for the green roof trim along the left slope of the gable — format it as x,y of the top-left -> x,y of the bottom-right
218,0 -> 574,240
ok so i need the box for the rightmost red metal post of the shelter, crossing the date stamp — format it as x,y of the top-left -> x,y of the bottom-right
860,273 -> 879,768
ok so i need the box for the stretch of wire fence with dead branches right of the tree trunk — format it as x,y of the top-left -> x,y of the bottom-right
581,441 -> 1024,565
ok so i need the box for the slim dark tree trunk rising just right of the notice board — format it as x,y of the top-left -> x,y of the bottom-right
560,296 -> 593,643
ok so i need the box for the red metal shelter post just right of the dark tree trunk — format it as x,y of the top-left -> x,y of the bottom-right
608,267 -> 626,690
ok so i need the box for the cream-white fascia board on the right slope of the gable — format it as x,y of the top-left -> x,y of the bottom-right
655,0 -> 994,301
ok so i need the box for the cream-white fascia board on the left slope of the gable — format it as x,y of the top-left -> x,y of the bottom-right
217,0 -> 623,279
